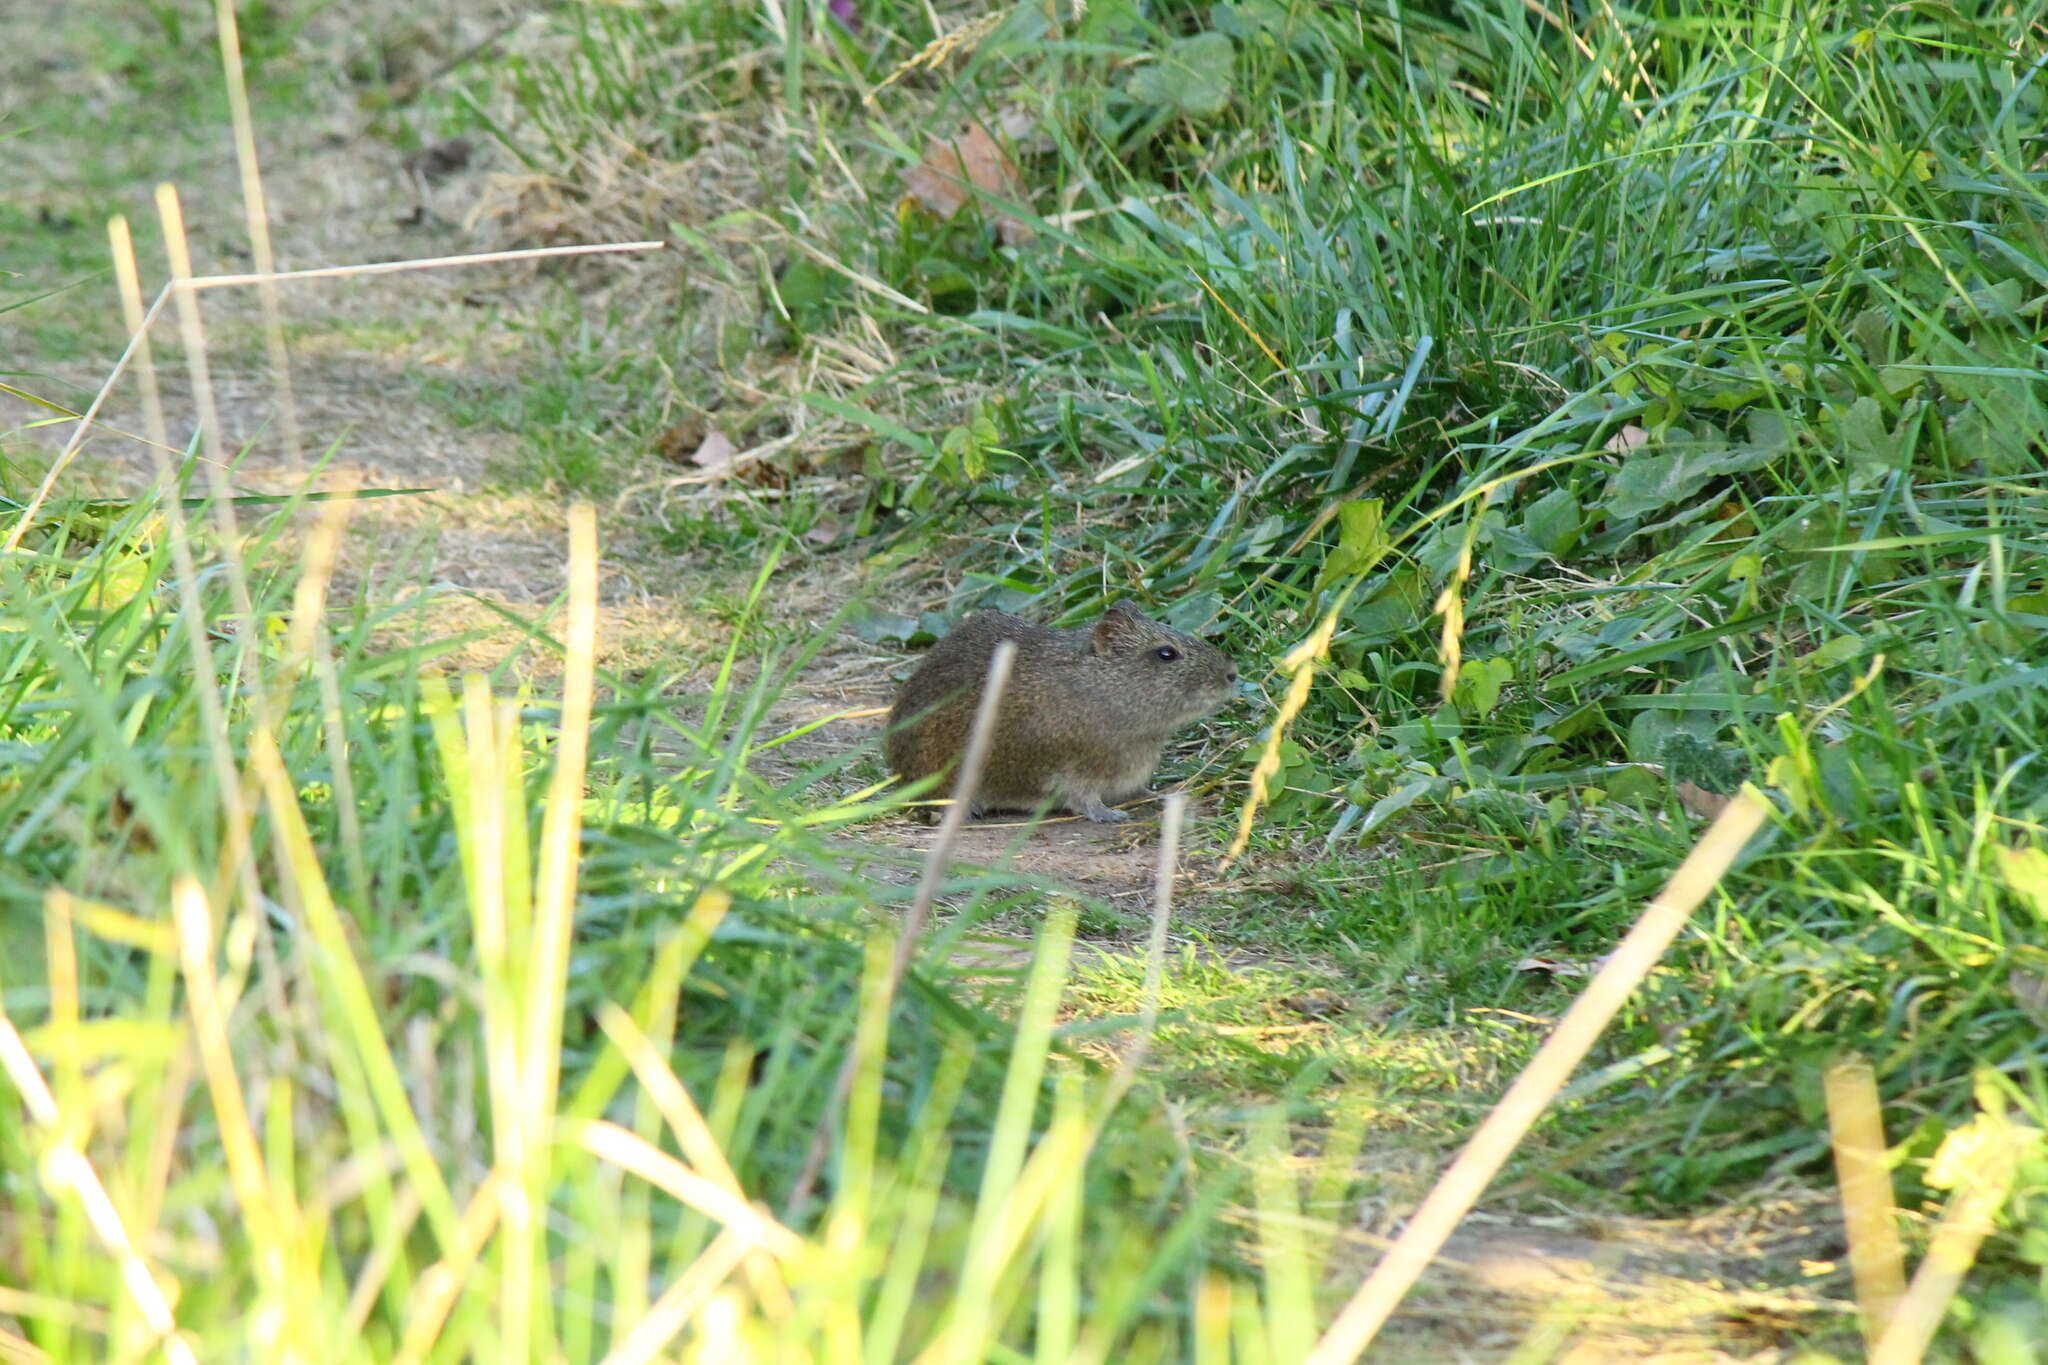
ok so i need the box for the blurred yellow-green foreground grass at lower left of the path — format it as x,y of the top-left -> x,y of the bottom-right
0,480 -> 1269,1361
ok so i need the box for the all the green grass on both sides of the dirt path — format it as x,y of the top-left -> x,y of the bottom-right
12,0 -> 2048,1361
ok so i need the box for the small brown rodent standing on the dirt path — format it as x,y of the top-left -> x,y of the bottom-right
885,602 -> 1237,821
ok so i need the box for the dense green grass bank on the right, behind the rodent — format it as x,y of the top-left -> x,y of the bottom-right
456,4 -> 2048,1342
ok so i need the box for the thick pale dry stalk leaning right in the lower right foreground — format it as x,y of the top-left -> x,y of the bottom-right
1307,788 -> 1767,1365
